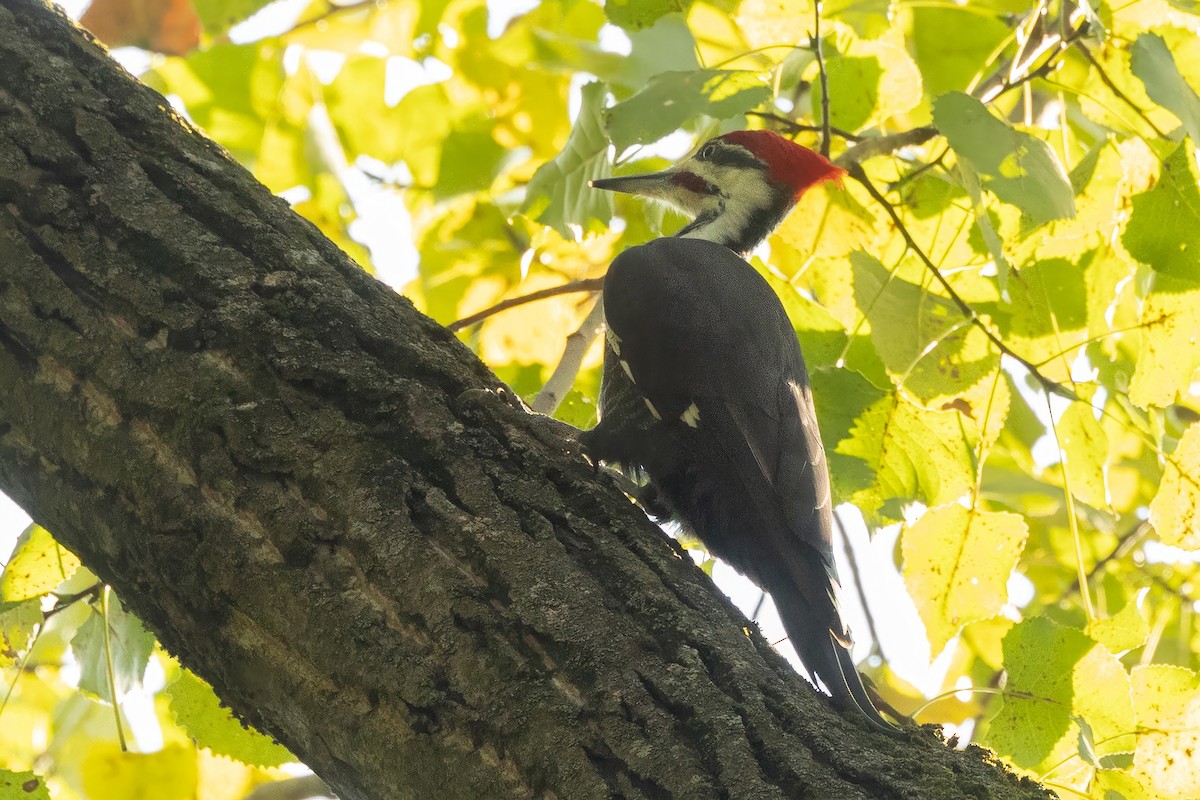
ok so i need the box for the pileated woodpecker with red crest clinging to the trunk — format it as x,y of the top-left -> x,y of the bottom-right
581,131 -> 895,732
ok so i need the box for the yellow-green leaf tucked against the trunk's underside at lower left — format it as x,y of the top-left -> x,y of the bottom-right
164,669 -> 296,766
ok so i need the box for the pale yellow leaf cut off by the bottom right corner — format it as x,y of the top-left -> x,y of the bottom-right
1133,664 -> 1200,798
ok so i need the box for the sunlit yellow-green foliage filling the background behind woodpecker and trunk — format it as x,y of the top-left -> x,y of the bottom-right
0,0 -> 1200,800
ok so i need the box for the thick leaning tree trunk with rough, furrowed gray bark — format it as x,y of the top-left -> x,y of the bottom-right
0,0 -> 1049,800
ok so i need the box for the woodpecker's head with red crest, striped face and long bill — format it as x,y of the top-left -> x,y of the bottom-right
590,131 -> 846,253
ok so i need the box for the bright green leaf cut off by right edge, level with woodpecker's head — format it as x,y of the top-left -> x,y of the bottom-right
1121,142 -> 1200,281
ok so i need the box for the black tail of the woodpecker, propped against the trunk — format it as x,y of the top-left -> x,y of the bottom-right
772,578 -> 900,736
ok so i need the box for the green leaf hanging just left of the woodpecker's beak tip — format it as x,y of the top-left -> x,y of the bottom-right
521,82 -> 612,237
